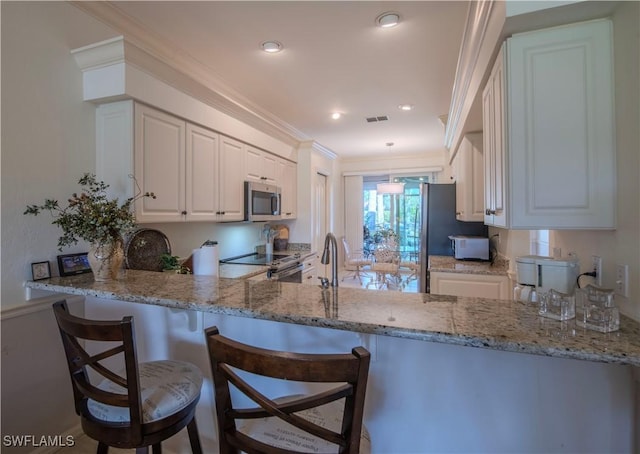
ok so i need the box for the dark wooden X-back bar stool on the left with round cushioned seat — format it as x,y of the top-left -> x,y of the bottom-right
53,300 -> 202,454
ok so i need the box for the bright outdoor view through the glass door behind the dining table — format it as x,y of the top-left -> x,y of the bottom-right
363,175 -> 429,259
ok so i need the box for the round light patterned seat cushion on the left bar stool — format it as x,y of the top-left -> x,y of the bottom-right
87,360 -> 202,424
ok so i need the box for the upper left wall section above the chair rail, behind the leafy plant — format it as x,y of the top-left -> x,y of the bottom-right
1,2 -> 115,308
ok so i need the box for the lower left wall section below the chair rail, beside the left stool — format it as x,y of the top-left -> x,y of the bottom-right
0,296 -> 84,454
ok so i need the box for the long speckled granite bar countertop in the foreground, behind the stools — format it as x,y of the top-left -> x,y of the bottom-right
26,270 -> 640,366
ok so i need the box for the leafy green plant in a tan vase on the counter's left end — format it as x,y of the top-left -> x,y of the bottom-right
24,173 -> 155,281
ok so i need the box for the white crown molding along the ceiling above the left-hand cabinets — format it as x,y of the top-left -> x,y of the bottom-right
71,1 -> 310,145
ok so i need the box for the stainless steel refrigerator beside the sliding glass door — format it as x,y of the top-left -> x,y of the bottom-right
419,183 -> 489,293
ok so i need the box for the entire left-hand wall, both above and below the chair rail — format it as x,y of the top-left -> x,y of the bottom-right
0,2 -> 117,453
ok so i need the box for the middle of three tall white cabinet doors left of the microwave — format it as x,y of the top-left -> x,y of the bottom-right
186,124 -> 220,221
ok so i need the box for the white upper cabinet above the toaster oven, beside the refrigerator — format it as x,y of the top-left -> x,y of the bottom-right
453,133 -> 484,222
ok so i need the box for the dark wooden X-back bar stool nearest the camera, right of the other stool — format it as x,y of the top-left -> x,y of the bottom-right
205,326 -> 370,454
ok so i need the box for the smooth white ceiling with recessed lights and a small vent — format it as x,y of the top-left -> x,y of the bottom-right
77,1 -> 468,159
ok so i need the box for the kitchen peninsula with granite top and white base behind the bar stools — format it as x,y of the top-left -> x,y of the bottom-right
27,270 -> 640,453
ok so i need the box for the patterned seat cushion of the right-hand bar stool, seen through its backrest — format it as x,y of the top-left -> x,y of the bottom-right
238,394 -> 371,454
